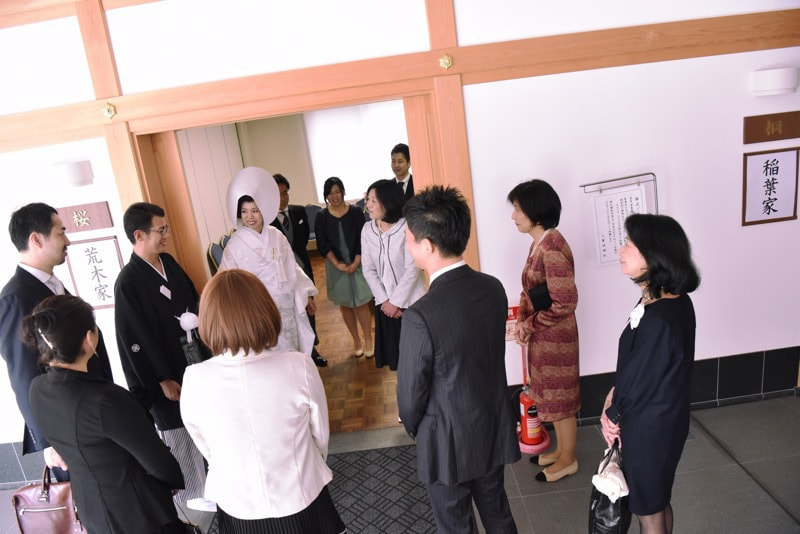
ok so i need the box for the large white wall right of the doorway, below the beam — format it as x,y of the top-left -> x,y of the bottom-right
464,48 -> 800,375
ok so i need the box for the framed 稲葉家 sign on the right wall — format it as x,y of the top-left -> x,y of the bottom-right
742,147 -> 800,226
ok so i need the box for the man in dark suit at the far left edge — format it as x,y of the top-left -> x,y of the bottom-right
0,202 -> 112,480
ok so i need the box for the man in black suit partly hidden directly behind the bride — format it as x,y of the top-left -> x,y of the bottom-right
270,174 -> 328,367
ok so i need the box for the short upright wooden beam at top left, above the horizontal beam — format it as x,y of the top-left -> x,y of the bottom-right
75,0 -> 122,99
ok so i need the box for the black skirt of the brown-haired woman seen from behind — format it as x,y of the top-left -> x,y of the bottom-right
217,486 -> 347,534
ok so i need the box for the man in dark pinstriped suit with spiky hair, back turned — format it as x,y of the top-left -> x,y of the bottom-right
397,186 -> 520,533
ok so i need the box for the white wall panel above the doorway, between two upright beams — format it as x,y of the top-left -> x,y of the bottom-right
106,0 -> 429,94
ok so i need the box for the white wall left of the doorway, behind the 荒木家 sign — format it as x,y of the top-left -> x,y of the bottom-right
0,139 -> 132,443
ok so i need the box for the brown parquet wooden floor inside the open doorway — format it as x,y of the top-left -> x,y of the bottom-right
309,252 -> 400,433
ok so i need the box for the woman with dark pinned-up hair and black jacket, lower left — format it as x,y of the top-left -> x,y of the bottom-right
22,295 -> 186,533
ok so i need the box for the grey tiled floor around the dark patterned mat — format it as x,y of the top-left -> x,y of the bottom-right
0,397 -> 800,534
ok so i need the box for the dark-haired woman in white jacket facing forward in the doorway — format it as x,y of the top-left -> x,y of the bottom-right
361,180 -> 425,371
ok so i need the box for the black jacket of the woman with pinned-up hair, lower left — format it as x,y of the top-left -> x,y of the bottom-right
30,367 -> 184,533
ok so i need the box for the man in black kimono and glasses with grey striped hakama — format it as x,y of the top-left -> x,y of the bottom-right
114,202 -> 216,511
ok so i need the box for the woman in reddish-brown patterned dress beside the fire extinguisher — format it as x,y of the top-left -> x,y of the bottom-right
508,180 -> 580,482
